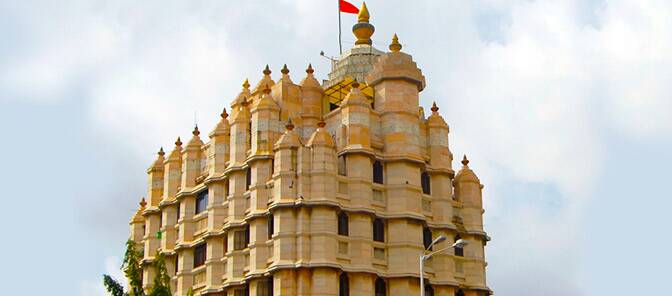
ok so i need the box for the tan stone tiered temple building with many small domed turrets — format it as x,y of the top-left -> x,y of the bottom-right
130,5 -> 491,296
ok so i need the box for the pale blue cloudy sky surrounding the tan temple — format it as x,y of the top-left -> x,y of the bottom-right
0,0 -> 672,296
